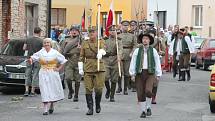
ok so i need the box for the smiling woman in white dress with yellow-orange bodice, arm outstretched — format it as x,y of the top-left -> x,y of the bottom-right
28,38 -> 67,115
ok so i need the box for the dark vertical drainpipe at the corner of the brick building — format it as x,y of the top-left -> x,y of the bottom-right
47,0 -> 52,38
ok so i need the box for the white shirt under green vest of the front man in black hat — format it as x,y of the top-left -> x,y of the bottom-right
129,48 -> 162,77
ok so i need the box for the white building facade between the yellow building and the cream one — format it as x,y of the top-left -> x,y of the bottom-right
147,0 -> 179,28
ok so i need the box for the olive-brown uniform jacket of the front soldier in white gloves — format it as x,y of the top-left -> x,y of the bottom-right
79,40 -> 105,72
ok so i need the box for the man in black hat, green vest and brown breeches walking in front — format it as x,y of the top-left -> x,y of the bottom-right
129,34 -> 162,118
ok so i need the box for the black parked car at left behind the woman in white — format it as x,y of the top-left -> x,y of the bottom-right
0,39 -> 64,86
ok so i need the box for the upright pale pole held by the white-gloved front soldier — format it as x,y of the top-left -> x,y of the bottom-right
97,2 -> 101,71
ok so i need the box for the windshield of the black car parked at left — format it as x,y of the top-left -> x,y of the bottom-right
1,40 -> 25,56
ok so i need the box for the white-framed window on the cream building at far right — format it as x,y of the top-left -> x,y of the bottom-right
193,5 -> 203,27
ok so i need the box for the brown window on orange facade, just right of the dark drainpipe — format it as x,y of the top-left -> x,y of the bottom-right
51,8 -> 66,25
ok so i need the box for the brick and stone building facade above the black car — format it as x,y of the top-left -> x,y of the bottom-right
0,0 -> 47,44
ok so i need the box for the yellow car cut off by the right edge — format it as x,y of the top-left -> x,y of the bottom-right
209,65 -> 215,113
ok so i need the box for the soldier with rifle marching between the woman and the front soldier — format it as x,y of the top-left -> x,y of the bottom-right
61,26 -> 81,102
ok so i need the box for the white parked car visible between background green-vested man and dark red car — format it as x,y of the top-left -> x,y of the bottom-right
191,36 -> 205,63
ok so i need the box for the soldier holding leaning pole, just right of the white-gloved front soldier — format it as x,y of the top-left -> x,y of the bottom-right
104,26 -> 123,102
